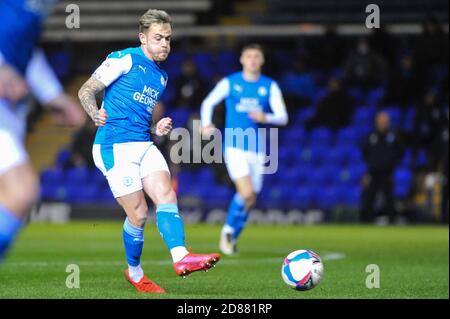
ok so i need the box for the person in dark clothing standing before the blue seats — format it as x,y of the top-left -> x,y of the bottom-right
360,112 -> 403,222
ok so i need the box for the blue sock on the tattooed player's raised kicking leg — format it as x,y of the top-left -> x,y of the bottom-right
156,204 -> 185,250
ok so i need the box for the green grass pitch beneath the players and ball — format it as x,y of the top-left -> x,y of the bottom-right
0,221 -> 449,299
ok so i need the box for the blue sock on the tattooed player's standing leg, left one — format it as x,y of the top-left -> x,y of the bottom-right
123,218 -> 144,267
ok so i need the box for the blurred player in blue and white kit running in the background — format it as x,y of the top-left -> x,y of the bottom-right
201,44 -> 288,255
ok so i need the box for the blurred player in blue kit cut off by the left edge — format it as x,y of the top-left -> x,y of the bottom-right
0,0 -> 85,259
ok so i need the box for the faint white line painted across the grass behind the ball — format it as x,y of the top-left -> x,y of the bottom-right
0,252 -> 346,271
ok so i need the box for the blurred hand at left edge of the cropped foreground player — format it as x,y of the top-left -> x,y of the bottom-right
0,64 -> 28,103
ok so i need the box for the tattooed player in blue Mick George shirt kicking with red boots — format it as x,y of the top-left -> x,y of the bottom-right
79,9 -> 220,293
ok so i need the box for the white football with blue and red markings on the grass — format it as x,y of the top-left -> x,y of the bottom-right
281,250 -> 323,291
